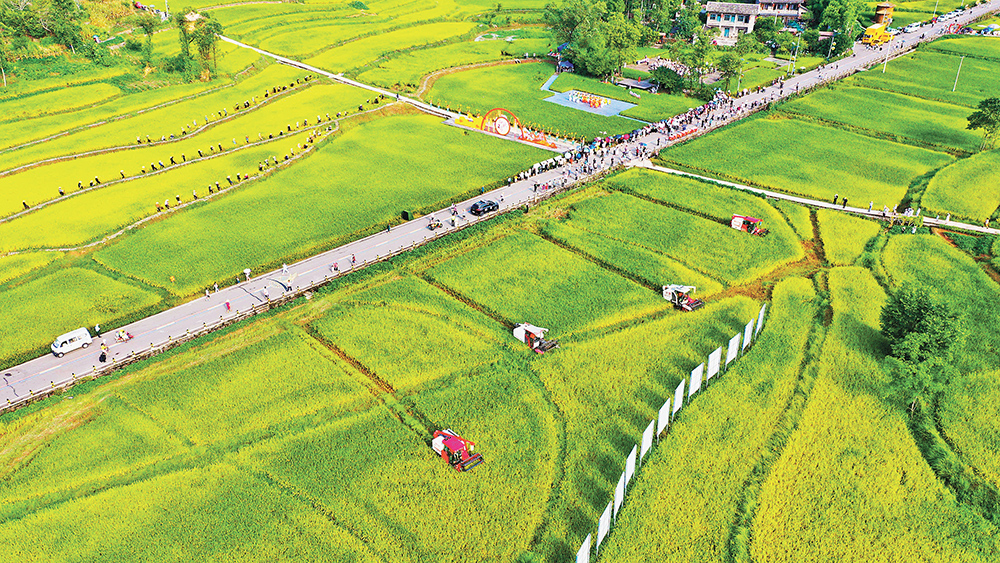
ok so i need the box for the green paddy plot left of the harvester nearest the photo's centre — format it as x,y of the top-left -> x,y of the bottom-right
312,277 -> 508,390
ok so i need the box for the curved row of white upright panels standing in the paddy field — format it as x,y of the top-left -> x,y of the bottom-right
576,303 -> 767,563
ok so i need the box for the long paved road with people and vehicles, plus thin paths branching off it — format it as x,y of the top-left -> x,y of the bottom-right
0,6 -> 1000,408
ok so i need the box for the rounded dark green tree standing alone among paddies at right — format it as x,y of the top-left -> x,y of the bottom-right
881,285 -> 964,412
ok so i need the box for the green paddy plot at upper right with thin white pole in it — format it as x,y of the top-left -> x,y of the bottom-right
850,51 -> 1000,109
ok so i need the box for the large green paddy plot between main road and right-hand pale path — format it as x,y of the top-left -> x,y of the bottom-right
660,119 -> 953,207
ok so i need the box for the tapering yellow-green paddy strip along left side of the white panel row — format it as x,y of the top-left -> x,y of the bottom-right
532,297 -> 760,560
